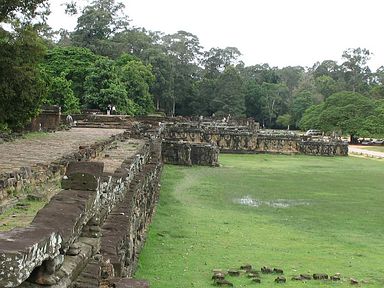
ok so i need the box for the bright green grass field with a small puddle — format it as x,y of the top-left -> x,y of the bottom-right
135,155 -> 384,288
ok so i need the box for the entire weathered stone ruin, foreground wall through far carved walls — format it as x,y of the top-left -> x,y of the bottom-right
0,115 -> 348,288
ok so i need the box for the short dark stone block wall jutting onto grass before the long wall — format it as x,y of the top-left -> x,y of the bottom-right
161,140 -> 219,166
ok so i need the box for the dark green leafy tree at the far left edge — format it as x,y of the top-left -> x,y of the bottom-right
0,26 -> 46,129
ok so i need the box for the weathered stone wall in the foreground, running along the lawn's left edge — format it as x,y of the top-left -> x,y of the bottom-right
0,135 -> 162,287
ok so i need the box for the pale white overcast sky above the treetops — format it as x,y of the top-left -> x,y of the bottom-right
49,0 -> 384,70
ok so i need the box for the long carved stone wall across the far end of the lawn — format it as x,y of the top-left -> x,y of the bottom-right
164,123 -> 348,156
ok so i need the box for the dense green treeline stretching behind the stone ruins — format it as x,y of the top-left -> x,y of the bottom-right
0,0 -> 384,136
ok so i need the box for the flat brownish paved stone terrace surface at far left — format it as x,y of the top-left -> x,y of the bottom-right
0,128 -> 125,174
